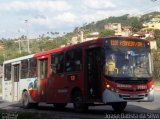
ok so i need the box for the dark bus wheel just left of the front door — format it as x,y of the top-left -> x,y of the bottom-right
72,91 -> 88,112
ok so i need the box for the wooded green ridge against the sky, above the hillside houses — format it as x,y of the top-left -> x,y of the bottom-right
73,12 -> 160,32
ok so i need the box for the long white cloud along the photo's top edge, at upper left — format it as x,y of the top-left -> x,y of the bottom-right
0,1 -> 71,11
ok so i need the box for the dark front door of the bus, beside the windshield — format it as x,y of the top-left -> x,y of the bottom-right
85,47 -> 102,99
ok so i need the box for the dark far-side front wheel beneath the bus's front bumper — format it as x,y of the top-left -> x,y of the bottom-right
112,102 -> 127,112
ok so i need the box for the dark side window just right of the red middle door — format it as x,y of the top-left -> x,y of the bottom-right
51,52 -> 64,74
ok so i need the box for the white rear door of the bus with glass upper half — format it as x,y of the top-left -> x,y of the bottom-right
12,63 -> 20,101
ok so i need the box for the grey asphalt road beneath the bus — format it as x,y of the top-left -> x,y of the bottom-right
0,90 -> 160,119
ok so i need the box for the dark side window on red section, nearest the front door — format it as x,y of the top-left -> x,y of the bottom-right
66,48 -> 82,72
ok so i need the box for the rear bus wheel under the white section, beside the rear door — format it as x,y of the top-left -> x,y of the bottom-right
22,91 -> 31,108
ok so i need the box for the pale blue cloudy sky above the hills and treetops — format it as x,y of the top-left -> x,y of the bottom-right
0,0 -> 160,38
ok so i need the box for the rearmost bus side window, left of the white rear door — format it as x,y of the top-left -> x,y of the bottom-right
4,64 -> 11,81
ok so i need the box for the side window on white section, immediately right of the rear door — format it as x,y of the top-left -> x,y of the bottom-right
21,59 -> 28,79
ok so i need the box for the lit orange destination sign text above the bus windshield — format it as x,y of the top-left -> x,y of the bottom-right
110,40 -> 143,47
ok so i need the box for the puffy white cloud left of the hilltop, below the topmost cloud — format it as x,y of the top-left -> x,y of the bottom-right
28,12 -> 77,29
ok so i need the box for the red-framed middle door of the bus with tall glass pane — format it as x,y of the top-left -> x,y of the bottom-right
38,56 -> 49,102
